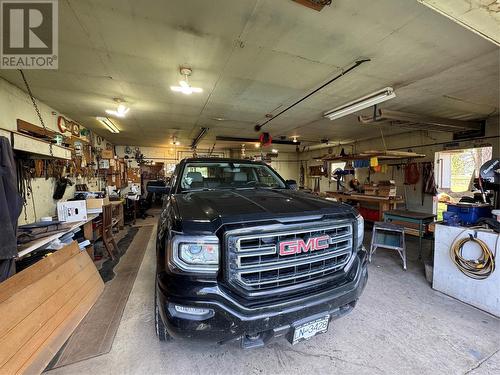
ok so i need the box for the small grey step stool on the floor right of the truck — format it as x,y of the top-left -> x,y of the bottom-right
368,221 -> 406,270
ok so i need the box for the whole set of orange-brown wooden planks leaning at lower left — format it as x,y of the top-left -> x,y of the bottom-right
0,242 -> 104,374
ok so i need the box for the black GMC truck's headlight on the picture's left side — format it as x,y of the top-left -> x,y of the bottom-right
169,235 -> 219,273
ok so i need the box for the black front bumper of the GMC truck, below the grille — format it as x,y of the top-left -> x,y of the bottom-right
156,250 -> 368,347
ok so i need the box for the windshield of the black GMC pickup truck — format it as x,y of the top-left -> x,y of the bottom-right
180,162 -> 285,191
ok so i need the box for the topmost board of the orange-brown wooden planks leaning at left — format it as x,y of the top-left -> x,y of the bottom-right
0,242 -> 80,306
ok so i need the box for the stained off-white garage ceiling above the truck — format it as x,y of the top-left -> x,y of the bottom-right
0,0 -> 500,150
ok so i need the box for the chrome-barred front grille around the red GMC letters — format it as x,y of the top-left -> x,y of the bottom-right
226,222 -> 353,292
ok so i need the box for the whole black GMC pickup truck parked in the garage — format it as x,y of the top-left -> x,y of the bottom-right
155,158 -> 368,348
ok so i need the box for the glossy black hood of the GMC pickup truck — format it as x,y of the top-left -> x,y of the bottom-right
173,189 -> 354,231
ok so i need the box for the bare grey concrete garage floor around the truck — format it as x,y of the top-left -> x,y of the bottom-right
50,222 -> 500,375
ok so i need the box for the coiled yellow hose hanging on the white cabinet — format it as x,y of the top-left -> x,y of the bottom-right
450,235 -> 495,280
